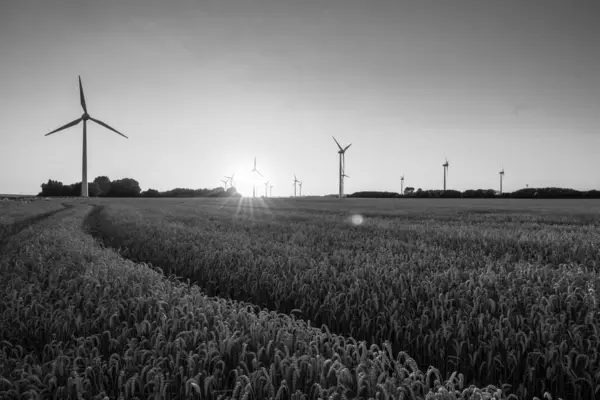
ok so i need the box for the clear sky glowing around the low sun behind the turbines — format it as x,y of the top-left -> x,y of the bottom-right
0,0 -> 600,196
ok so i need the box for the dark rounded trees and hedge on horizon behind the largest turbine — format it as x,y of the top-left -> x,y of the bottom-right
38,176 -> 240,197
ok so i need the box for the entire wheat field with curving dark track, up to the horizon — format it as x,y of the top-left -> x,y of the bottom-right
0,198 -> 600,399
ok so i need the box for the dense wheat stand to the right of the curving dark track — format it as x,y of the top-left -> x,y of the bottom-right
88,205 -> 600,399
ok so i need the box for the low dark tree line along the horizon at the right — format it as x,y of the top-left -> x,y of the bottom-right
347,187 -> 600,199
